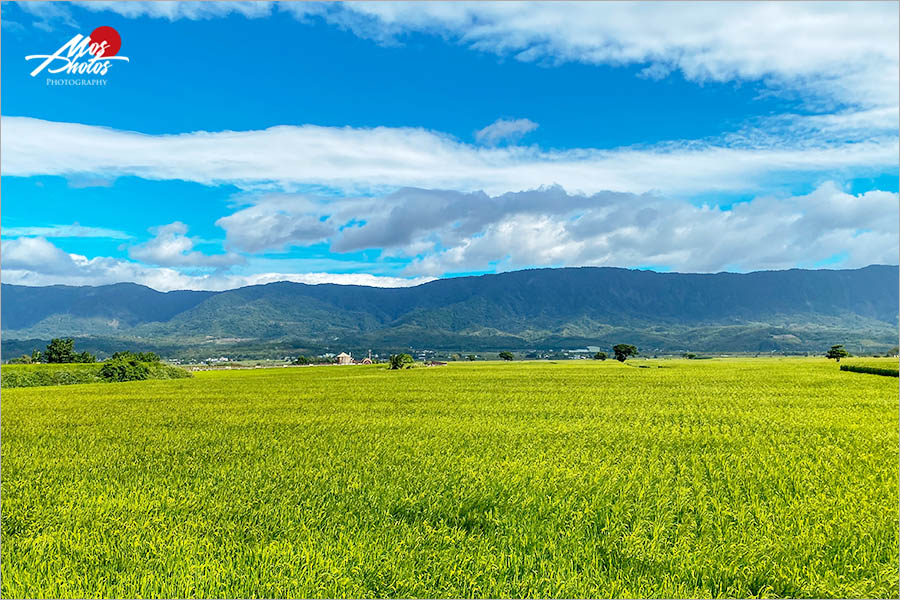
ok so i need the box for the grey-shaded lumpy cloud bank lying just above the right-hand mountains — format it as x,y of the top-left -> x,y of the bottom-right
197,182 -> 900,276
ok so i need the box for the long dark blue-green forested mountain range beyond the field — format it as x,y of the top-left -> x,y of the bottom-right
0,266 -> 900,352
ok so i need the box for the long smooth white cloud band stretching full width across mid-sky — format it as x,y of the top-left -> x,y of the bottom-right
0,117 -> 898,199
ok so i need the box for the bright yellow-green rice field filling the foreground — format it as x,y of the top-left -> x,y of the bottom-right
2,358 -> 900,598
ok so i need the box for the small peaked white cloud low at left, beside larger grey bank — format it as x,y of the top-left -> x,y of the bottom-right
128,221 -> 244,267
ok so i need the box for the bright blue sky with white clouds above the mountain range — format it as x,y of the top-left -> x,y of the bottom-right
2,2 -> 898,289
